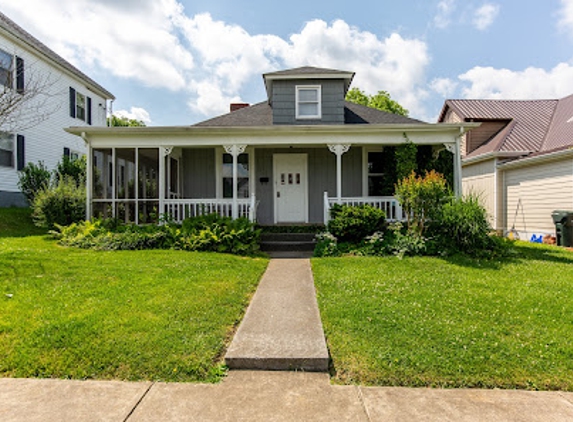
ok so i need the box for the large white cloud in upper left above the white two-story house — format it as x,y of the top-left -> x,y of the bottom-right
0,0 -> 194,90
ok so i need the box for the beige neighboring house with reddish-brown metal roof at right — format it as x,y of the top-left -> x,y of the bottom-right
438,96 -> 573,240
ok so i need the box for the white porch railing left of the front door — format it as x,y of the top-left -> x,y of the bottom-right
163,195 -> 257,223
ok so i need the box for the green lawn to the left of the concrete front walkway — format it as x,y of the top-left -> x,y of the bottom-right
0,209 -> 267,382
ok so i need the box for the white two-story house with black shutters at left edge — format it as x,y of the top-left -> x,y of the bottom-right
0,13 -> 114,207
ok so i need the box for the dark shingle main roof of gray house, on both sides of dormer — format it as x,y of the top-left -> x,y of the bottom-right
193,101 -> 426,127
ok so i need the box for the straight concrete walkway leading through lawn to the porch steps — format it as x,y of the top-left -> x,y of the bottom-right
225,258 -> 329,372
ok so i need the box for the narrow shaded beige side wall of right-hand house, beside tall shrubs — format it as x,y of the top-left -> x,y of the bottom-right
462,160 -> 497,228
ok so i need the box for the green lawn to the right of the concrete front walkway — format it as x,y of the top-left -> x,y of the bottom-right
312,243 -> 573,391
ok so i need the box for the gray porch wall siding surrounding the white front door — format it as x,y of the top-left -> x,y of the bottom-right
255,146 -> 362,224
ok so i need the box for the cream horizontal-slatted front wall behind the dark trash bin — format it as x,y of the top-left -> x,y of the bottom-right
503,158 -> 573,239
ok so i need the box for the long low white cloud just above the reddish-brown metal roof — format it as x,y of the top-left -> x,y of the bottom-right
459,63 -> 573,99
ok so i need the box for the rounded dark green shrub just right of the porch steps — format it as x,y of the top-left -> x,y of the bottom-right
327,204 -> 386,243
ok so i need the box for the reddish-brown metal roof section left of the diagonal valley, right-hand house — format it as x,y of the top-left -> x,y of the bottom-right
439,100 -> 559,157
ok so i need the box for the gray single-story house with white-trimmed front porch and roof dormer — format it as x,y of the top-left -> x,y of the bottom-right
68,67 -> 479,224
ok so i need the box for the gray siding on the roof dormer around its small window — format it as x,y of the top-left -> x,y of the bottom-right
272,79 -> 344,125
